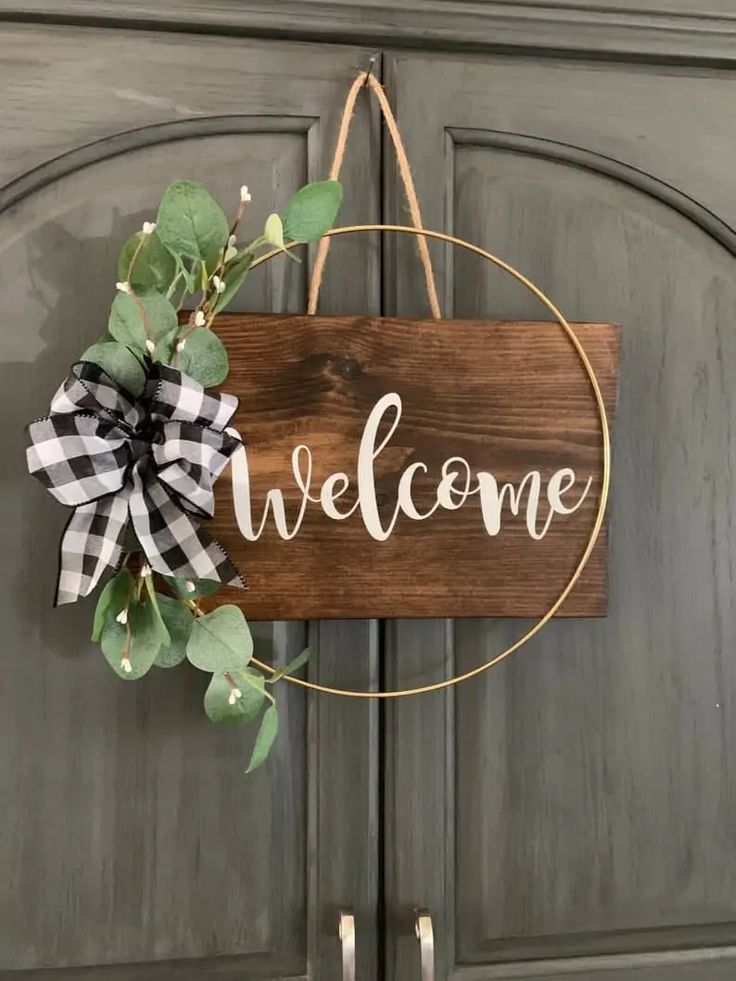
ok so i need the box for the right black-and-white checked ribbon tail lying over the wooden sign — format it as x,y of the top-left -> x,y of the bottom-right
129,468 -> 245,587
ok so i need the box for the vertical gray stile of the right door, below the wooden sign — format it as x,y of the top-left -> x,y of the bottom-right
384,620 -> 464,981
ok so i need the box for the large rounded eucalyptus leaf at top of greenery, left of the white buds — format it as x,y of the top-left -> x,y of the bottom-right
156,181 -> 230,262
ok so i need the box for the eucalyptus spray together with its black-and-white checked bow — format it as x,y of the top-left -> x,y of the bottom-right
27,180 -> 342,771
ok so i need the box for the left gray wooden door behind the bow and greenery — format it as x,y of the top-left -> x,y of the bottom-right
0,25 -> 380,981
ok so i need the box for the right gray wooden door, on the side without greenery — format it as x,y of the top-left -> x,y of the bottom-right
385,47 -> 736,981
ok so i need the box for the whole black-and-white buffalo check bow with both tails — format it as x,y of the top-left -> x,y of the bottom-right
26,361 -> 245,606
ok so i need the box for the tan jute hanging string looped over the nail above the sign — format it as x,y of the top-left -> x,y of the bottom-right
307,69 -> 442,320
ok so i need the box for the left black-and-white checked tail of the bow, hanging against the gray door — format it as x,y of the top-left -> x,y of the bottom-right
55,488 -> 129,606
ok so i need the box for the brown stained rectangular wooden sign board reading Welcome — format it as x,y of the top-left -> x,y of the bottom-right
210,314 -> 618,620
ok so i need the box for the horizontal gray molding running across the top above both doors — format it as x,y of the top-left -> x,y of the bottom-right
0,0 -> 736,67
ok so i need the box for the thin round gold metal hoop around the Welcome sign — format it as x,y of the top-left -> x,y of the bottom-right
247,225 -> 611,698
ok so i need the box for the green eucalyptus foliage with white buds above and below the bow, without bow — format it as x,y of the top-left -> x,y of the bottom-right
82,174 -> 342,772
